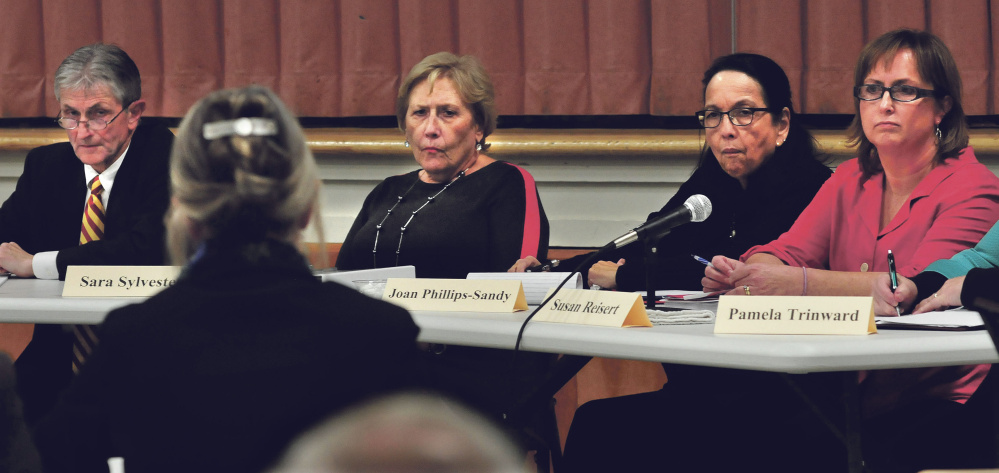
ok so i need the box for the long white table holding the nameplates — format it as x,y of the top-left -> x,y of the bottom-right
0,279 -> 999,373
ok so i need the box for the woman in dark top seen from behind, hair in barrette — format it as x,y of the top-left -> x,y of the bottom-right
36,87 -> 418,472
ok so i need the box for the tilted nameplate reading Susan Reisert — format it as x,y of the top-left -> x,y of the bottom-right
534,289 -> 652,327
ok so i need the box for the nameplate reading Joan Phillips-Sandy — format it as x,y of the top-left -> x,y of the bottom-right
382,278 -> 527,312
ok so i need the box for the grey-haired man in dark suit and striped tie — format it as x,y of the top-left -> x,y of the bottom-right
0,44 -> 173,422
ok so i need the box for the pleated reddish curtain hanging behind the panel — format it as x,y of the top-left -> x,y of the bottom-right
0,0 -> 999,117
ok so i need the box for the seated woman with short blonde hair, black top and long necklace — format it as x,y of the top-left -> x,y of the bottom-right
336,52 -> 554,419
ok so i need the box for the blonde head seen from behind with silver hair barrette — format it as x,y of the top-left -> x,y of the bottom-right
167,86 -> 321,264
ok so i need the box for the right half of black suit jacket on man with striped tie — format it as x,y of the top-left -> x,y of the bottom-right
56,125 -> 173,279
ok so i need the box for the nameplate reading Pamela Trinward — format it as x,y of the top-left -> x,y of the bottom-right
715,296 -> 878,335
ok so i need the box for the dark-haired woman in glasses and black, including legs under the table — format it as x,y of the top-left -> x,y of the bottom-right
560,53 -> 831,472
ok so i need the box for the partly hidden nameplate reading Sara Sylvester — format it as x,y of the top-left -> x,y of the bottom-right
62,266 -> 181,297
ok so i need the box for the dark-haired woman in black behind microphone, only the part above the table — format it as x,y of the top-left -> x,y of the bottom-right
510,53 -> 831,291
